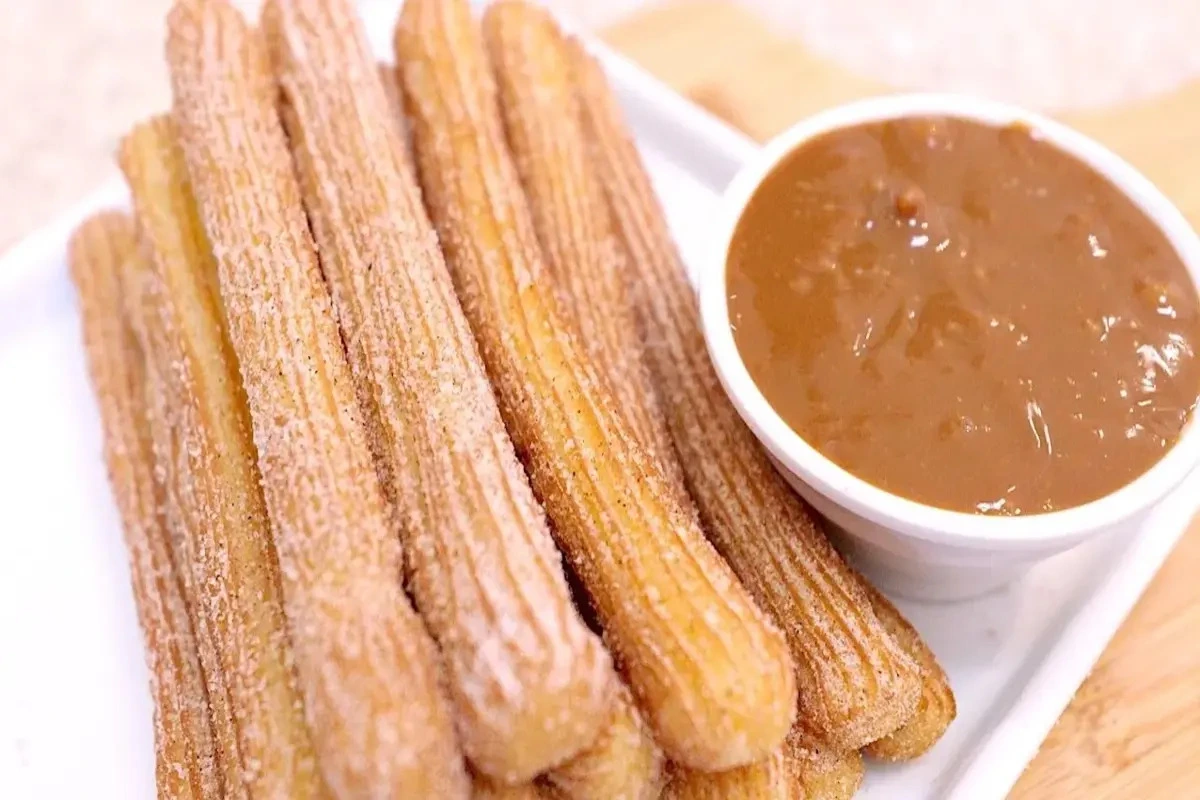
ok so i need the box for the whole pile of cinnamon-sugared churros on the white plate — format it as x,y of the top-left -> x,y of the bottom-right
71,0 -> 955,800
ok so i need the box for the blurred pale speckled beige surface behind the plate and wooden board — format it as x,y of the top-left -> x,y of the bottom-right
7,0 -> 1200,251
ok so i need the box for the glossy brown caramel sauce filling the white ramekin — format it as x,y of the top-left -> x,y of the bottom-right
727,118 -> 1200,515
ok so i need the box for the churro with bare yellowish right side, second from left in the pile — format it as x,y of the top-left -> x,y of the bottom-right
119,116 -> 325,798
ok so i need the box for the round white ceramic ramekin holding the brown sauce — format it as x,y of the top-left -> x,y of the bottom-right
700,94 -> 1200,600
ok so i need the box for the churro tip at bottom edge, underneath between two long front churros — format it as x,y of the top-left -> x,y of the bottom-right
545,684 -> 665,800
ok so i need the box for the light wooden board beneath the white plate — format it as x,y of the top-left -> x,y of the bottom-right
604,0 -> 1200,800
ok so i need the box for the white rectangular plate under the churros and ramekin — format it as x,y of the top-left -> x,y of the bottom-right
0,2 -> 1200,800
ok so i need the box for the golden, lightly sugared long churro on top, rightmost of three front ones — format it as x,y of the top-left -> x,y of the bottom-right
396,0 -> 794,769
